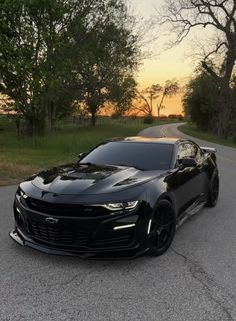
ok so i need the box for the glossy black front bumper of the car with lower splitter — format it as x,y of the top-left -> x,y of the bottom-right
10,192 -> 149,258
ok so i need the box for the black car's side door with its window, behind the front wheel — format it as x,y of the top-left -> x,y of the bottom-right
165,141 -> 206,214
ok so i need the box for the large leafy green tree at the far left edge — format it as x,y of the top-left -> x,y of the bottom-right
0,0 -> 92,135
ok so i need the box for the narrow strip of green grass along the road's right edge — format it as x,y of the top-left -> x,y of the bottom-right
178,123 -> 236,148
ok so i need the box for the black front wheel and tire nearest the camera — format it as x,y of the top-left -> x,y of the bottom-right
148,200 -> 176,256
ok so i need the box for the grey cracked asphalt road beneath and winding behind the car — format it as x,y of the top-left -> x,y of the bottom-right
0,125 -> 236,321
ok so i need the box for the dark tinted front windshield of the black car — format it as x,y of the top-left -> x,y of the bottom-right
81,142 -> 173,170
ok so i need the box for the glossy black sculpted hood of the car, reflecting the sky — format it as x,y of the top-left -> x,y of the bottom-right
31,164 -> 165,195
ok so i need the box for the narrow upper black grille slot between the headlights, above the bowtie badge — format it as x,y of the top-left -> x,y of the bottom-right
24,197 -> 109,217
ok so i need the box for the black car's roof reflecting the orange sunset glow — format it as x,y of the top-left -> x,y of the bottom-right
107,136 -> 183,145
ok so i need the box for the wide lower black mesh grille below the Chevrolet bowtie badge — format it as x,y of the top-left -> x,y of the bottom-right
28,220 -> 134,249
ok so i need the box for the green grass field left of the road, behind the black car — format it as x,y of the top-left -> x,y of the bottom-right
0,117 -> 175,185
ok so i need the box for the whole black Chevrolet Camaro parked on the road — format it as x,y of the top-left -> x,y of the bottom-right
10,137 -> 219,257
